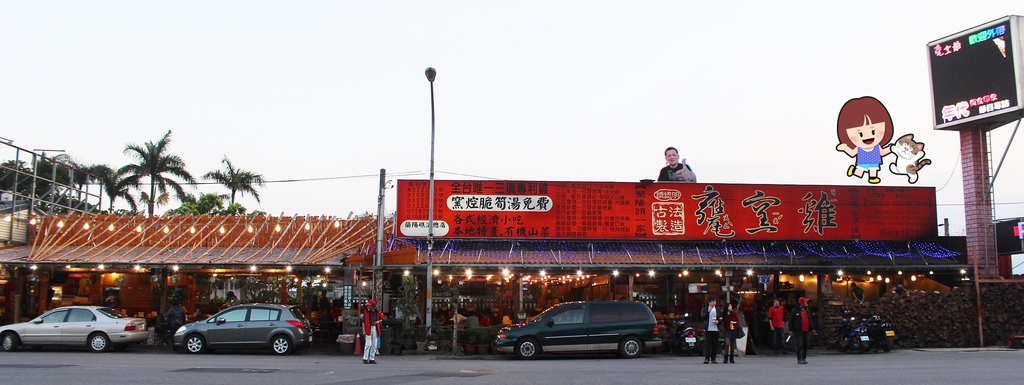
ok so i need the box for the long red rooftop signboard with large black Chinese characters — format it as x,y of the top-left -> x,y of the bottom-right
396,180 -> 937,241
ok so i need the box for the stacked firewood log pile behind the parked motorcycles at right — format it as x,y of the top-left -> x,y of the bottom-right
819,284 -> 1024,348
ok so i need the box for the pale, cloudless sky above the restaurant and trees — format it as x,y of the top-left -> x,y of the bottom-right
0,0 -> 1024,270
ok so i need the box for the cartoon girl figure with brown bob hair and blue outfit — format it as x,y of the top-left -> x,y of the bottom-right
836,96 -> 893,184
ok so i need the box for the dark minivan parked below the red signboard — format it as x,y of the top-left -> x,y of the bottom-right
495,301 -> 662,358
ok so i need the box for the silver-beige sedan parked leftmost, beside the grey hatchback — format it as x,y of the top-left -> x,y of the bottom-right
0,306 -> 150,351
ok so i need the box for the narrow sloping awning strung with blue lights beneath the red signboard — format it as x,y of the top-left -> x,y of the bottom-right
376,239 -> 966,269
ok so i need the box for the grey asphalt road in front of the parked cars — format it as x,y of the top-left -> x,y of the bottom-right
0,347 -> 1024,385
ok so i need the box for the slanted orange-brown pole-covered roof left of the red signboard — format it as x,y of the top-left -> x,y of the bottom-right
0,214 -> 390,265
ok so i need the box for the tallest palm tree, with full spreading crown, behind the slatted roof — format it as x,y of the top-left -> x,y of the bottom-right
118,130 -> 196,217
